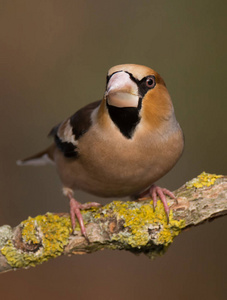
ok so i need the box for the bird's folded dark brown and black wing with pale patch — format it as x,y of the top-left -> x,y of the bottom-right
49,100 -> 101,158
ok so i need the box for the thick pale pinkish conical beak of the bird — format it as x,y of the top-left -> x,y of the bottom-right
106,71 -> 139,107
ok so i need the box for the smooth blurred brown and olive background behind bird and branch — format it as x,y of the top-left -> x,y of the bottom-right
0,0 -> 227,300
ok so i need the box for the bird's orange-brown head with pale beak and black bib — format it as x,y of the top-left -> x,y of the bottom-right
101,64 -> 173,137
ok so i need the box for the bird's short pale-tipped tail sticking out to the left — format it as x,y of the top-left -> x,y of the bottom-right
17,144 -> 55,166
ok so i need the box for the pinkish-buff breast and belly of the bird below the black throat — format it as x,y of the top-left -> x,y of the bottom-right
54,119 -> 183,197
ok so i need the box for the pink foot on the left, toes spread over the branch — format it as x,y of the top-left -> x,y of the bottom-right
69,197 -> 102,241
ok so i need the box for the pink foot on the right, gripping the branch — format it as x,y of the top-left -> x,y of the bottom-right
139,184 -> 176,223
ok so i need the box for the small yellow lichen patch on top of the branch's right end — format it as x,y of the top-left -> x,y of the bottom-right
186,172 -> 222,189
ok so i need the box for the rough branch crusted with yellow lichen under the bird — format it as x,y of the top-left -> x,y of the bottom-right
0,173 -> 227,272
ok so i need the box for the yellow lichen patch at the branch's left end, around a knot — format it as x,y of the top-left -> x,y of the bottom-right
1,213 -> 72,268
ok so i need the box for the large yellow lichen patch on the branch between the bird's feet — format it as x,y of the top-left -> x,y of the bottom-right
96,201 -> 184,248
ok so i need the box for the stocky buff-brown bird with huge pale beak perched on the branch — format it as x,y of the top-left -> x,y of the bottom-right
18,64 -> 184,239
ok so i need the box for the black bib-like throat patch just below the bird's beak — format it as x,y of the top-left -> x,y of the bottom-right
107,99 -> 141,139
